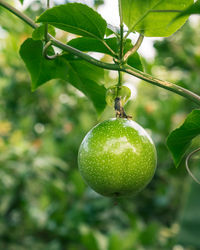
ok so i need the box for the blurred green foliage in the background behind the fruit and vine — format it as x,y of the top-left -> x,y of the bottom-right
0,1 -> 200,250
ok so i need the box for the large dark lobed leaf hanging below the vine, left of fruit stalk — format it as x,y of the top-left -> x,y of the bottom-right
20,38 -> 106,114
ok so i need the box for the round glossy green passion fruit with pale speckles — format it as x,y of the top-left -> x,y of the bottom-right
78,118 -> 157,197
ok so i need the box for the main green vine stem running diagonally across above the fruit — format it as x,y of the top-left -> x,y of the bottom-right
0,0 -> 200,106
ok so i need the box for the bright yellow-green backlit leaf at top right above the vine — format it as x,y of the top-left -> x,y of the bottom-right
122,0 -> 194,37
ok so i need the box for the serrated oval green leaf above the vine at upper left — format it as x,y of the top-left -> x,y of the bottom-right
37,3 -> 107,39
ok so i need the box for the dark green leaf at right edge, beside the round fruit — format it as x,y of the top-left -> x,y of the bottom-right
167,109 -> 200,167
